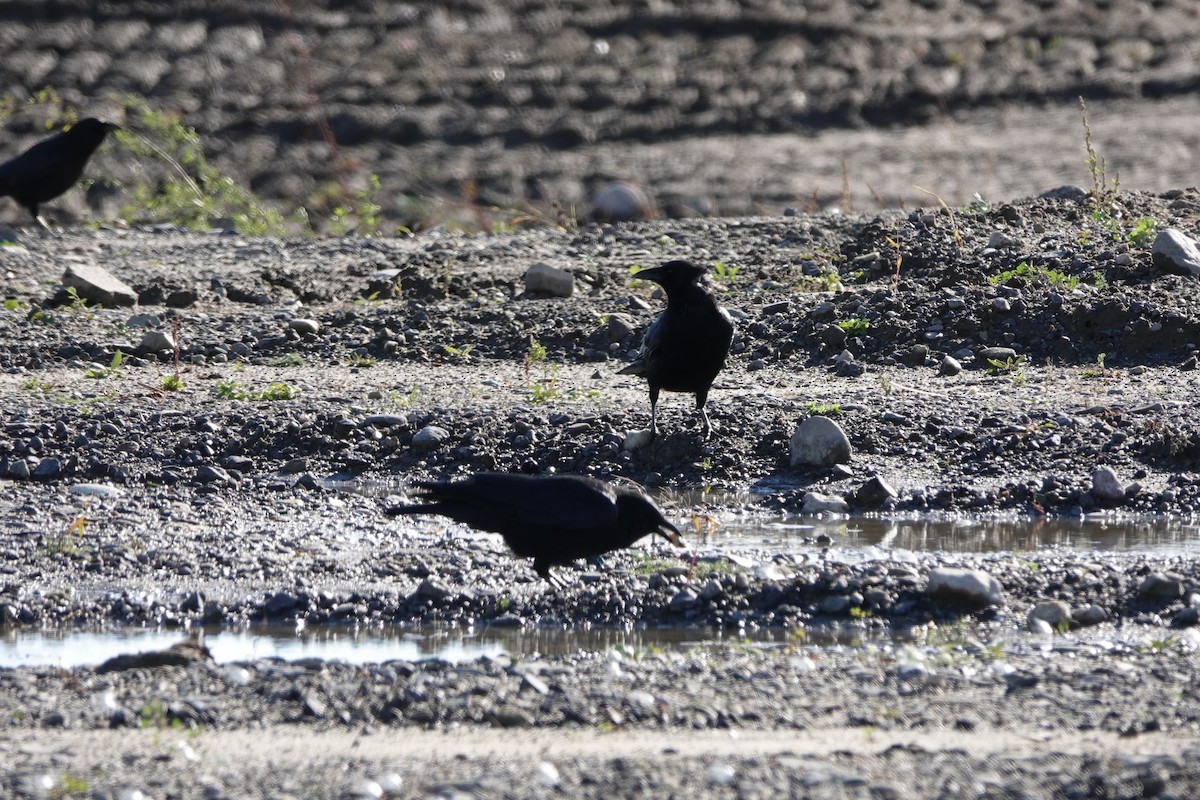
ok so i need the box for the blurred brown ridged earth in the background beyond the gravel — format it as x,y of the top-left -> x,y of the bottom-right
0,0 -> 1200,233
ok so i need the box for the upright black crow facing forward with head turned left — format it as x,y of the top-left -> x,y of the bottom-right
617,261 -> 733,439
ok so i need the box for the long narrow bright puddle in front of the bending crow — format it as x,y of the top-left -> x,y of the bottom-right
0,625 -> 806,668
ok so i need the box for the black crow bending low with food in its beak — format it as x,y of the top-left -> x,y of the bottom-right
390,473 -> 683,583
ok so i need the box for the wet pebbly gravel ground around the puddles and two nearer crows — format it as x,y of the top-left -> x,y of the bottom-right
0,191 -> 1200,798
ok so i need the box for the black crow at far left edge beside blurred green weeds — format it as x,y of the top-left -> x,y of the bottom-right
0,116 -> 120,230
